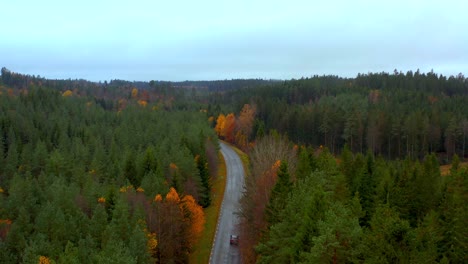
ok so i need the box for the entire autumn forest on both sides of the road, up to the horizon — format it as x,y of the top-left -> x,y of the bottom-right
0,68 -> 468,263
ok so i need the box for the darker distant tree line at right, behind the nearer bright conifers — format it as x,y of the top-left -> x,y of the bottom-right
208,71 -> 468,162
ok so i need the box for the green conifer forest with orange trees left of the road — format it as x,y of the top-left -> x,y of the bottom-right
0,69 -> 218,263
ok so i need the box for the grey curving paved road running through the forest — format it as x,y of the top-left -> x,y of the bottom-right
210,143 -> 244,264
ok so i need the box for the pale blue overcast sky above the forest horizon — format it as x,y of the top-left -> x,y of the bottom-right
0,0 -> 468,81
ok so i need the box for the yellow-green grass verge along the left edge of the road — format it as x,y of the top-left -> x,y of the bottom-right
189,152 -> 226,264
